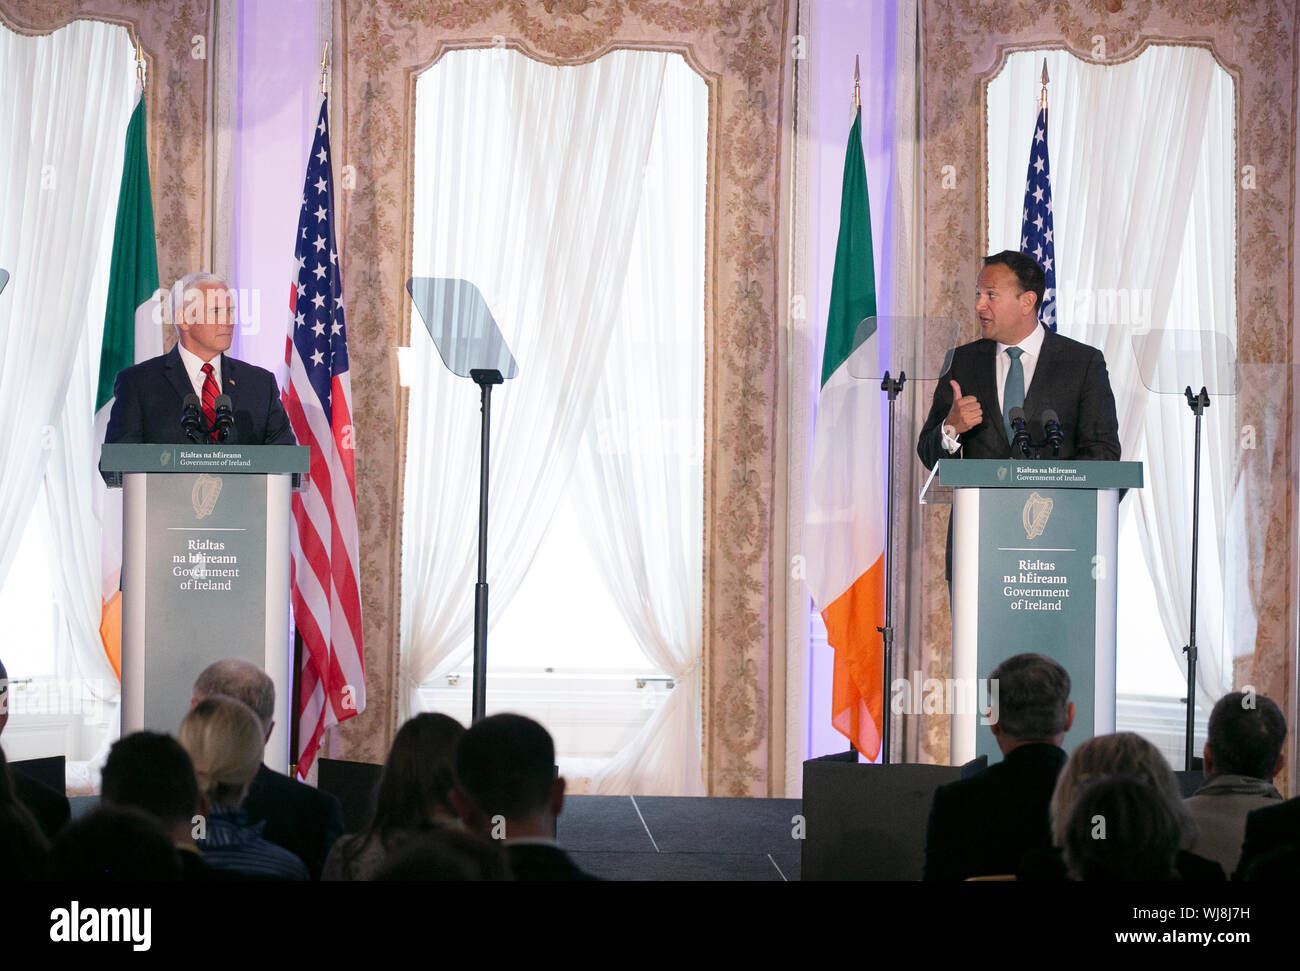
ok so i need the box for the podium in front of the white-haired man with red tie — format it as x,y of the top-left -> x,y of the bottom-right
99,445 -> 311,772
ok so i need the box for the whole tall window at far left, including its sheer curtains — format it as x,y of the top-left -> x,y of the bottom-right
0,21 -> 135,789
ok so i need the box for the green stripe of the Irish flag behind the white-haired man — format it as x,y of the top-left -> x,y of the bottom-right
95,95 -> 159,412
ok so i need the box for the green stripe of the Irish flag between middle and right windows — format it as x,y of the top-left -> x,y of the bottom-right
822,108 -> 876,386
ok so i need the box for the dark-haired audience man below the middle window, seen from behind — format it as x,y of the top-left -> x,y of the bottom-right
451,715 -> 594,880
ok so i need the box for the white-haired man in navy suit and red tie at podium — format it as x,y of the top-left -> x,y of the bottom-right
104,273 -> 296,445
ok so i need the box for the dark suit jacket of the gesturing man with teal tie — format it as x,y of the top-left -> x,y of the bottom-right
917,330 -> 1119,468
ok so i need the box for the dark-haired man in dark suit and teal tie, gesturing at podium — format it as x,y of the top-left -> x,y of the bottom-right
917,250 -> 1119,578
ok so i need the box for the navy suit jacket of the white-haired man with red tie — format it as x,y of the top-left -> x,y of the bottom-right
104,347 -> 298,445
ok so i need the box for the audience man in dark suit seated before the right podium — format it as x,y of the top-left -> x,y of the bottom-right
924,654 -> 1074,880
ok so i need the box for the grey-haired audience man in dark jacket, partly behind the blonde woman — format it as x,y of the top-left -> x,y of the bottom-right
190,658 -> 343,880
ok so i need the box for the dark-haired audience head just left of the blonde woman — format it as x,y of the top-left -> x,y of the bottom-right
100,732 -> 199,844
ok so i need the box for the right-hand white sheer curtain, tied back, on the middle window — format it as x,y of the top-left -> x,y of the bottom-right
576,57 -> 709,796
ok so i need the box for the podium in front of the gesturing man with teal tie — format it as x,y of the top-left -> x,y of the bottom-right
937,459 -> 1143,766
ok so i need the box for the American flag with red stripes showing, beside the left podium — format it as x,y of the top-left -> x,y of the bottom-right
283,99 -> 365,776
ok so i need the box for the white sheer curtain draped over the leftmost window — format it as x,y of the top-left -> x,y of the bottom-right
0,21 -> 135,722
